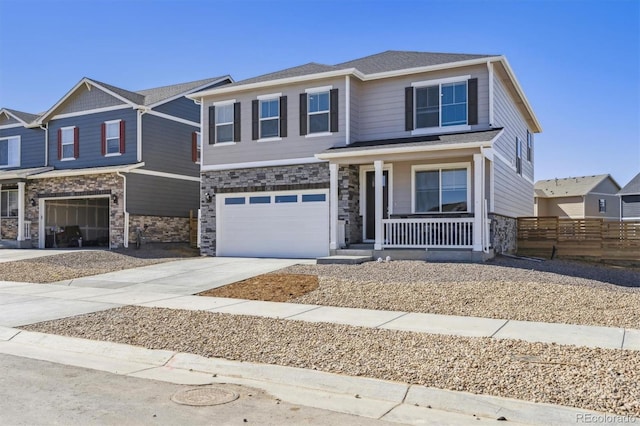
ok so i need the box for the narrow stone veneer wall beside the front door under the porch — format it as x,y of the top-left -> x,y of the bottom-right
338,165 -> 362,246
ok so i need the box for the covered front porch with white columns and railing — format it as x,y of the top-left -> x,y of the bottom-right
317,131 -> 498,261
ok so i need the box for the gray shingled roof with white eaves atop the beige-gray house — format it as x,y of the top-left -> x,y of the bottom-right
187,50 -> 542,133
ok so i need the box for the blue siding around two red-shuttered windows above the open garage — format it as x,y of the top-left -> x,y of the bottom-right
48,108 -> 137,169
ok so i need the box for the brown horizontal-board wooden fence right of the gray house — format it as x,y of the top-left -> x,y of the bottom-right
518,217 -> 640,262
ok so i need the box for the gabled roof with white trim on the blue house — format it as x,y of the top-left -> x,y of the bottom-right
39,75 -> 232,123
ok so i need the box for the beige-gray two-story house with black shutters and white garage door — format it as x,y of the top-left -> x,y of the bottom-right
188,51 -> 541,258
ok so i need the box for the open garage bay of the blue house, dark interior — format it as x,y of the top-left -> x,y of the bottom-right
44,196 -> 110,248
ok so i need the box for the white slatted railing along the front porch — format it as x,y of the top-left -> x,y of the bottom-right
382,217 -> 473,248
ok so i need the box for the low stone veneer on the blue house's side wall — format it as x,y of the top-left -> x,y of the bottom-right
129,215 -> 189,245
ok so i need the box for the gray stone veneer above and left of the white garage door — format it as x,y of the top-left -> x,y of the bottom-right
200,163 -> 329,256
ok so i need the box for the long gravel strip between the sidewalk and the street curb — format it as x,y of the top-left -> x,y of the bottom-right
23,306 -> 640,416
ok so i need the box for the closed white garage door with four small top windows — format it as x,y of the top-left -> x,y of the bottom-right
216,190 -> 329,259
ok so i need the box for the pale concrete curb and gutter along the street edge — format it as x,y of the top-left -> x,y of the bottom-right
0,326 -> 640,425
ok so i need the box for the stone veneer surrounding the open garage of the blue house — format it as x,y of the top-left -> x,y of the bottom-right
25,173 -> 124,248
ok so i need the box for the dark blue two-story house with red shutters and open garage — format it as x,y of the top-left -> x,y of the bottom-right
0,76 -> 232,248
